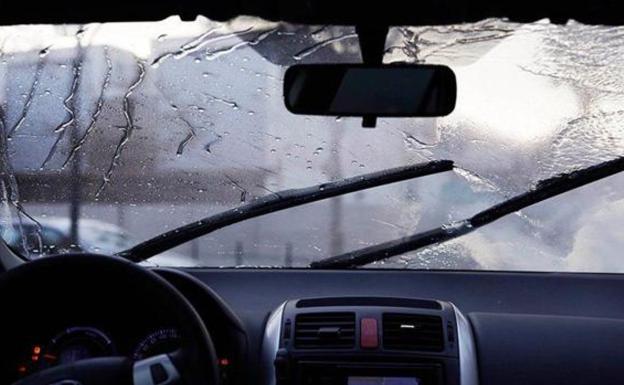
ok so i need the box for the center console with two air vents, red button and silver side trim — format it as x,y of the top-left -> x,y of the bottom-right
263,297 -> 478,385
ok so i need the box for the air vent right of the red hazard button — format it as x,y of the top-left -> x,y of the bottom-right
383,314 -> 444,352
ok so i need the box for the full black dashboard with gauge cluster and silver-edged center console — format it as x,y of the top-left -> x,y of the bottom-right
0,269 -> 624,385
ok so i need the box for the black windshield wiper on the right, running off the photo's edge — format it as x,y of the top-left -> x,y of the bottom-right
310,157 -> 624,269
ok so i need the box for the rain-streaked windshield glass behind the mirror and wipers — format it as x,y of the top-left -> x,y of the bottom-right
0,17 -> 624,272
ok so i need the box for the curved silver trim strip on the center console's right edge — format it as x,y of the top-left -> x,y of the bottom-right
451,304 -> 479,385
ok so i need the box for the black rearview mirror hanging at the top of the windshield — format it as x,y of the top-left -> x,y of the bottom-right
284,64 -> 457,117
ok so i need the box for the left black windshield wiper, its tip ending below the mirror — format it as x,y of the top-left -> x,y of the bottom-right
116,160 -> 453,262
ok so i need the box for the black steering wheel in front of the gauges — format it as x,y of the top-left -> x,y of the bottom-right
0,254 -> 218,385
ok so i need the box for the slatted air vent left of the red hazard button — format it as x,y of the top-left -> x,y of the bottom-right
295,313 -> 355,349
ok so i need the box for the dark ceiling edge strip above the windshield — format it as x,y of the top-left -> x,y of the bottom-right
0,0 -> 624,25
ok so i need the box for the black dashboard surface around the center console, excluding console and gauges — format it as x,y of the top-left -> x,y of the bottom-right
189,269 -> 624,385
